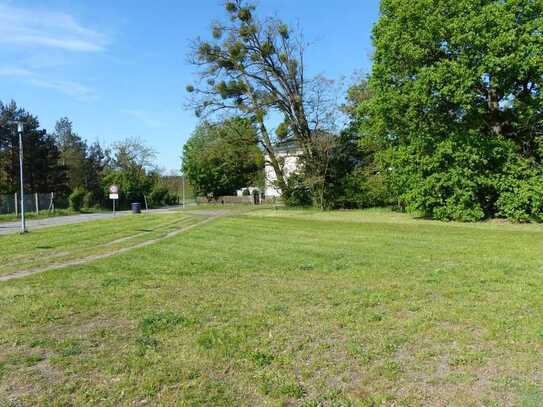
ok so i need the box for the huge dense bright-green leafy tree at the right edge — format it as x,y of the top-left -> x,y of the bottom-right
357,0 -> 543,221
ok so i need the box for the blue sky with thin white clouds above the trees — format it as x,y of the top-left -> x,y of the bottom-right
0,0 -> 379,171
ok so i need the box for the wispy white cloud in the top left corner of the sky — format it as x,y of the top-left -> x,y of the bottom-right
0,3 -> 108,52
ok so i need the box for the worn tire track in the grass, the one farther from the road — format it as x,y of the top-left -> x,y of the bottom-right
0,215 -> 216,282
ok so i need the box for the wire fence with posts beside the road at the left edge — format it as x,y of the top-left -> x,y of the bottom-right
0,192 -> 69,214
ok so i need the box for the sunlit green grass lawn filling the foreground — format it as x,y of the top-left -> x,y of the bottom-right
0,209 -> 543,406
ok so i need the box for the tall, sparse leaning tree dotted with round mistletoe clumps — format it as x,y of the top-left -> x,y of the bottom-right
187,0 -> 340,206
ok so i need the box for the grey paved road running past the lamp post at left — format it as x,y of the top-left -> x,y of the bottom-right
0,206 -> 181,235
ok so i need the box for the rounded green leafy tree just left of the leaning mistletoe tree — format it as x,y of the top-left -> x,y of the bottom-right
182,118 -> 264,197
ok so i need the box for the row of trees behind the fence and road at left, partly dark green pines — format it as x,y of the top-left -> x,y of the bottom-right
0,102 -> 180,210
